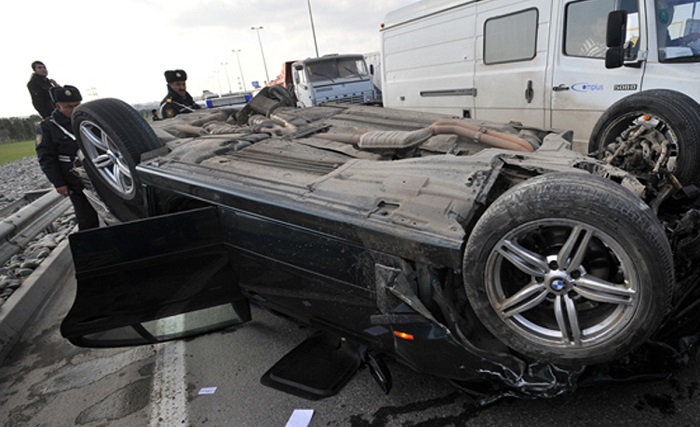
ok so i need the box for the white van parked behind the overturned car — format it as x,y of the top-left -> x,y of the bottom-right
381,0 -> 700,154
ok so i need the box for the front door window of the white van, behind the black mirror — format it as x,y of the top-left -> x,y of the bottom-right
564,0 -> 639,59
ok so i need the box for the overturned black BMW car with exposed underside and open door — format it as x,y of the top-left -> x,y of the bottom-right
61,90 -> 700,402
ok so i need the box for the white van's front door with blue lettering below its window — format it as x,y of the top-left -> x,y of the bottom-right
549,0 -> 647,152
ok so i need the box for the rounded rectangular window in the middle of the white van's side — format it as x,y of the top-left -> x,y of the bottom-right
484,9 -> 539,64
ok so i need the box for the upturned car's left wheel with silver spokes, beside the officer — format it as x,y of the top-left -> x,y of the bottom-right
73,98 -> 162,221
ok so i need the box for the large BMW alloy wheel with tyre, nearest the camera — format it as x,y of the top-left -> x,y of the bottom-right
462,173 -> 674,366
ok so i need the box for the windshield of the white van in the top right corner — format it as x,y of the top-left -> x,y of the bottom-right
654,0 -> 700,62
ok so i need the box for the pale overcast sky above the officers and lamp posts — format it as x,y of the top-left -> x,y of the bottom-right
0,0 -> 416,117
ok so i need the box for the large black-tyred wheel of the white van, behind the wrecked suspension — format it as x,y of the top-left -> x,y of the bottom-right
588,89 -> 700,184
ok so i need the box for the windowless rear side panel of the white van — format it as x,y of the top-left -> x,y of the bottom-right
382,0 -> 476,117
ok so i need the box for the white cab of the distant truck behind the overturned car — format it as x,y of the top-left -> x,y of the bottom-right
291,54 -> 376,107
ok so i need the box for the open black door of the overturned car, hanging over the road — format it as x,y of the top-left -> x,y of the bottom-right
61,207 -> 250,347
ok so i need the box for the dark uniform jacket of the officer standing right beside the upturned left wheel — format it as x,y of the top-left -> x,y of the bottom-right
36,110 -> 83,192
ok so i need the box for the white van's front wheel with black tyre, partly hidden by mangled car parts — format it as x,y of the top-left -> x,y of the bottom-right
588,89 -> 700,184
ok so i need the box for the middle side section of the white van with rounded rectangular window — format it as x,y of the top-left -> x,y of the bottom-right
474,0 -> 551,126
